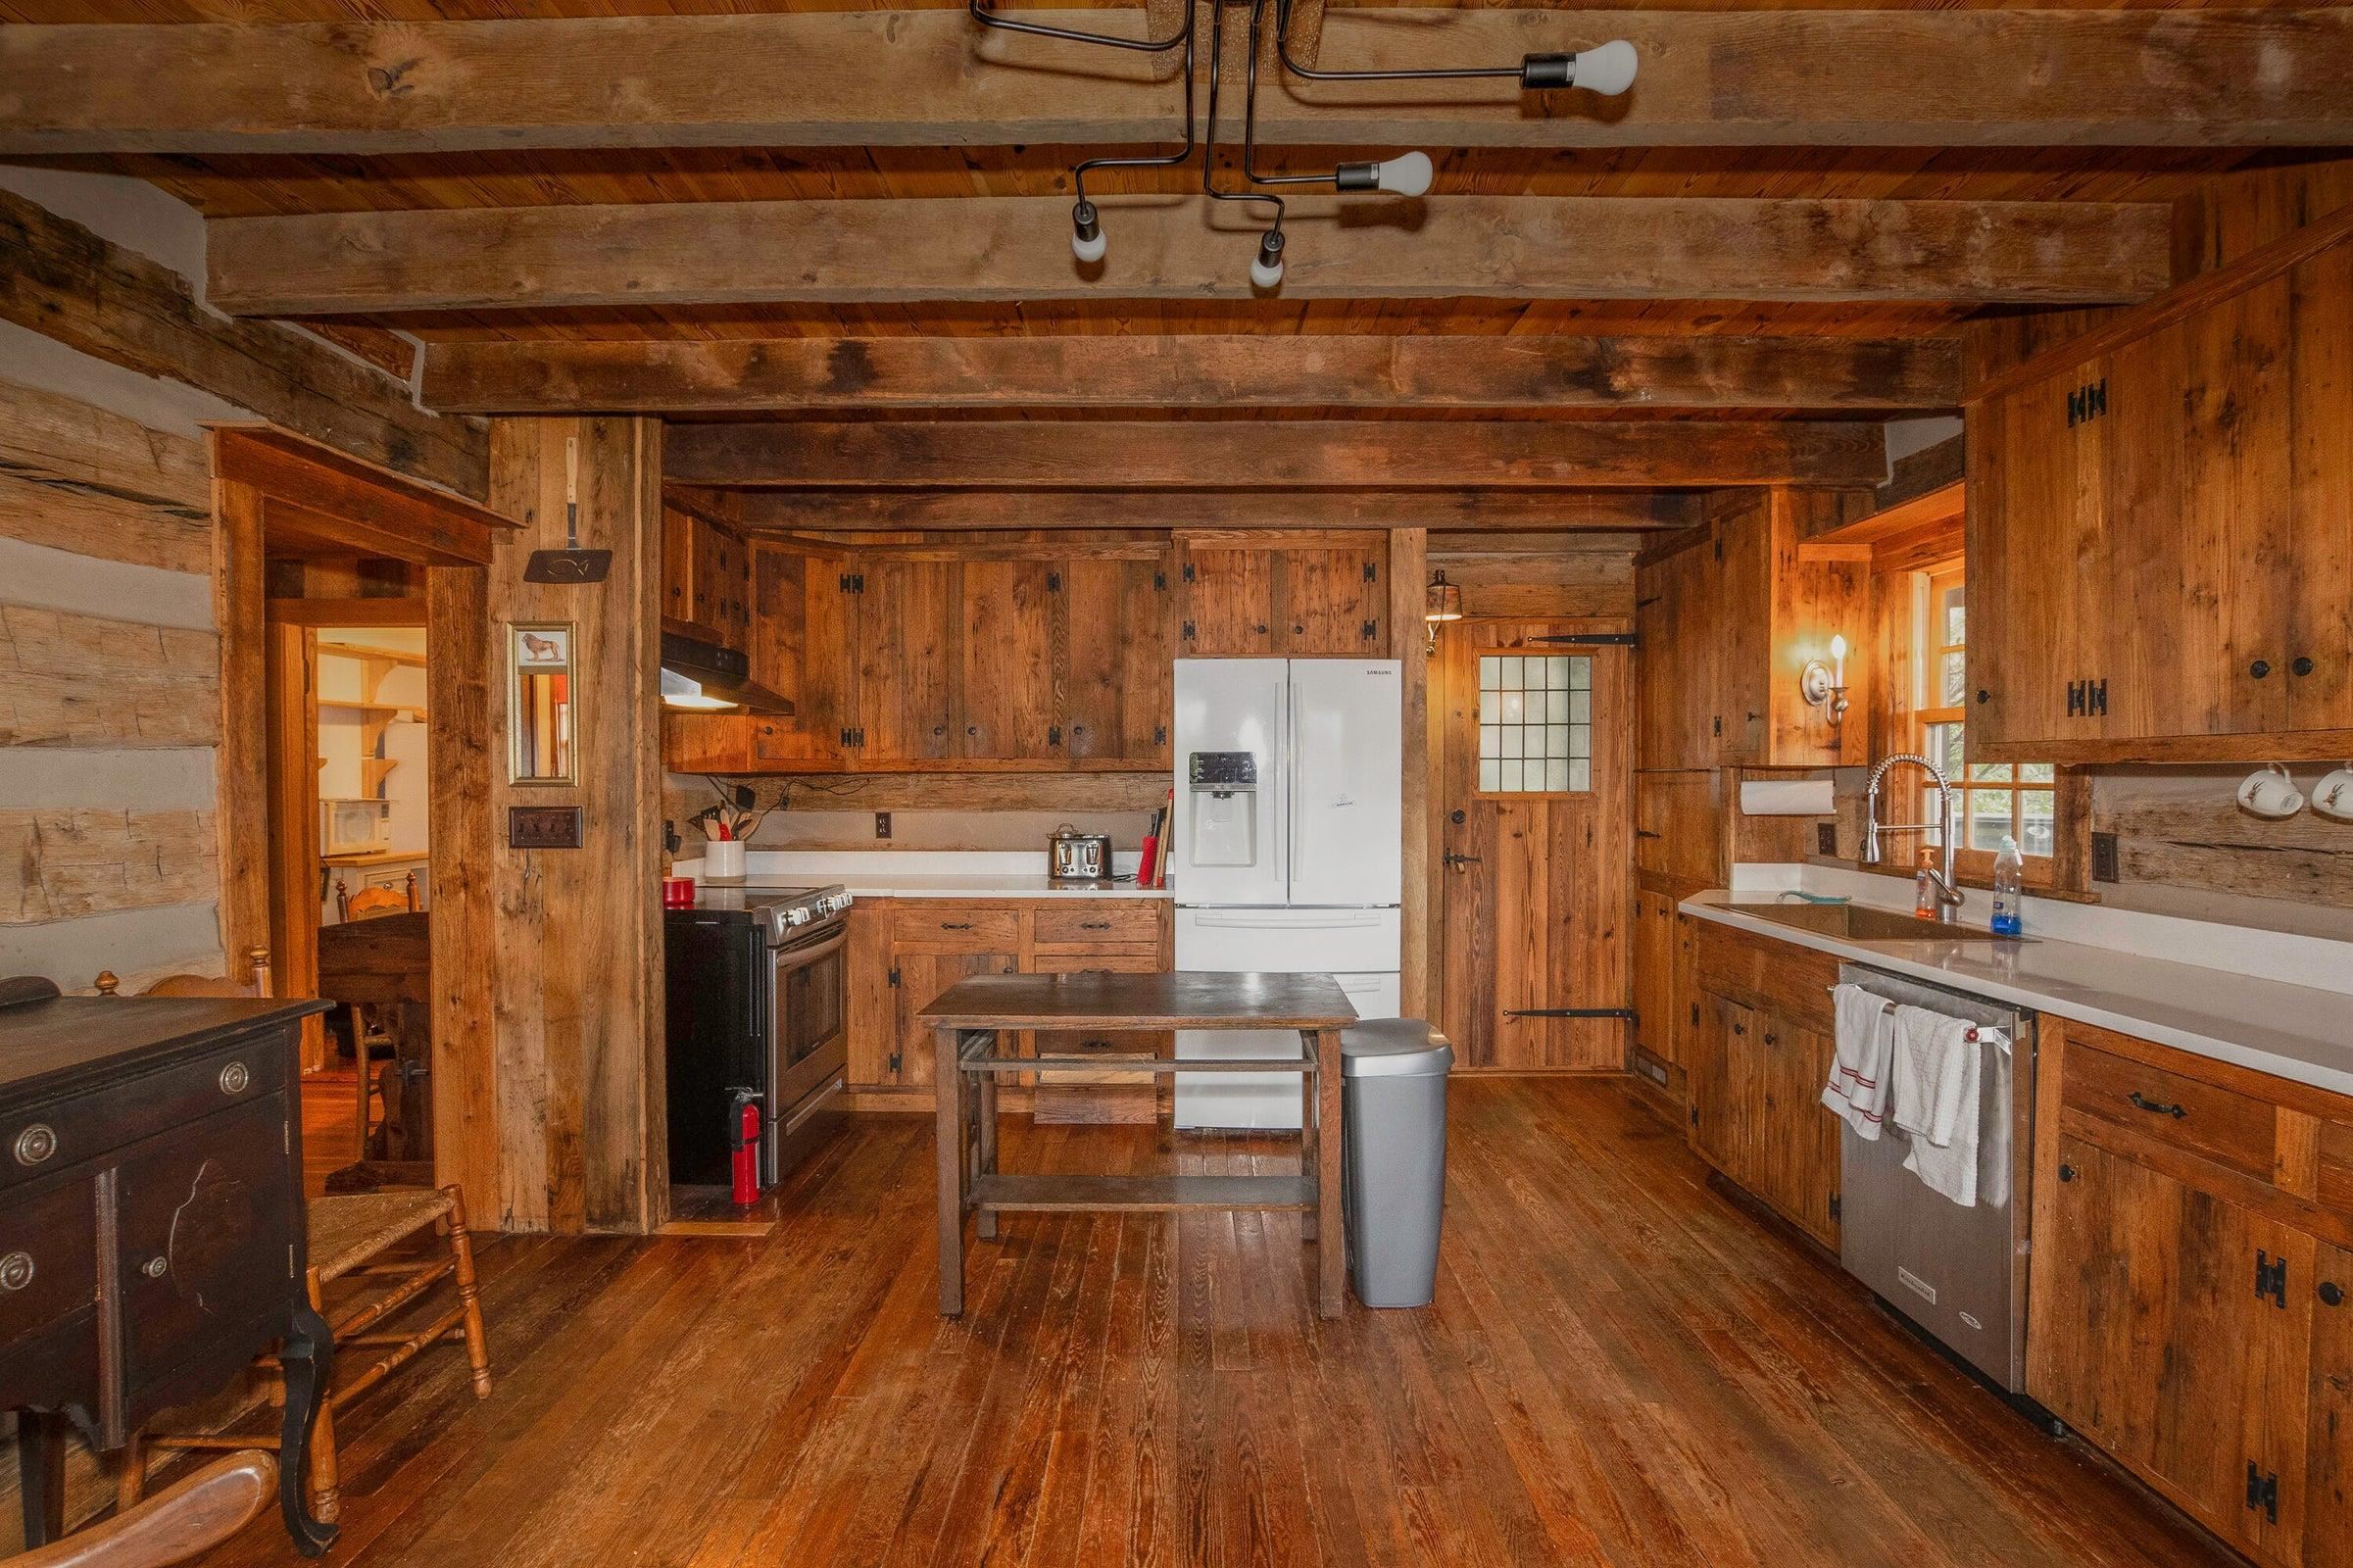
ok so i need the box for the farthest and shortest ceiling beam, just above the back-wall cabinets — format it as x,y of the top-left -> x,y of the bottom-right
706,490 -> 1701,531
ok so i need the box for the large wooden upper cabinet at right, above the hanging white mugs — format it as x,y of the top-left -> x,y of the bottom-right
1967,220 -> 2353,762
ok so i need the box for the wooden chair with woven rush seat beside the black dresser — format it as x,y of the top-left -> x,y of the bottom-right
116,1187 -> 489,1523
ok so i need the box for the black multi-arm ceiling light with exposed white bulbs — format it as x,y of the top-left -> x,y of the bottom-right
964,0 -> 1638,289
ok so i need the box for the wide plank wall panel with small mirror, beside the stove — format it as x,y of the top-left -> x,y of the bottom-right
489,419 -> 668,1231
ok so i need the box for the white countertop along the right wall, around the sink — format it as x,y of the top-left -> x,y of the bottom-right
1683,878 -> 2353,1095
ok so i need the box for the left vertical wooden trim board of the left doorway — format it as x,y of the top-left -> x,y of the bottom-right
212,470 -> 270,969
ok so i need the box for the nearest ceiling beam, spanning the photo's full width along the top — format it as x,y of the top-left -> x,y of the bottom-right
0,0 -> 2353,156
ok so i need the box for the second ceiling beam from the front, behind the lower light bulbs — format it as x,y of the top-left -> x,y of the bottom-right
207,195 -> 2172,316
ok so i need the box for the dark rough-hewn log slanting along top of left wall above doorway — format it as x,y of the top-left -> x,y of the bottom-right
0,191 -> 489,497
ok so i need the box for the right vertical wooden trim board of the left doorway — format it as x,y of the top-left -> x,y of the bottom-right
426,567 -> 501,1224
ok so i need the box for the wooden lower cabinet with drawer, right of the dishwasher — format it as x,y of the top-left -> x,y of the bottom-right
2026,1017 -> 2353,1568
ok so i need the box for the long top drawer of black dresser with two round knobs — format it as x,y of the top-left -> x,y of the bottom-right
0,1029 -> 287,1189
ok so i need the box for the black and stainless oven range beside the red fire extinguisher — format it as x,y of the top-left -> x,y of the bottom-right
663,888 -> 850,1187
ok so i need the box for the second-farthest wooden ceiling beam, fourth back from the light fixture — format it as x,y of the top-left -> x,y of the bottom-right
663,419 -> 1887,490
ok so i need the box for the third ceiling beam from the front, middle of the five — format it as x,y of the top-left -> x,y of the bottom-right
423,334 -> 1960,415
